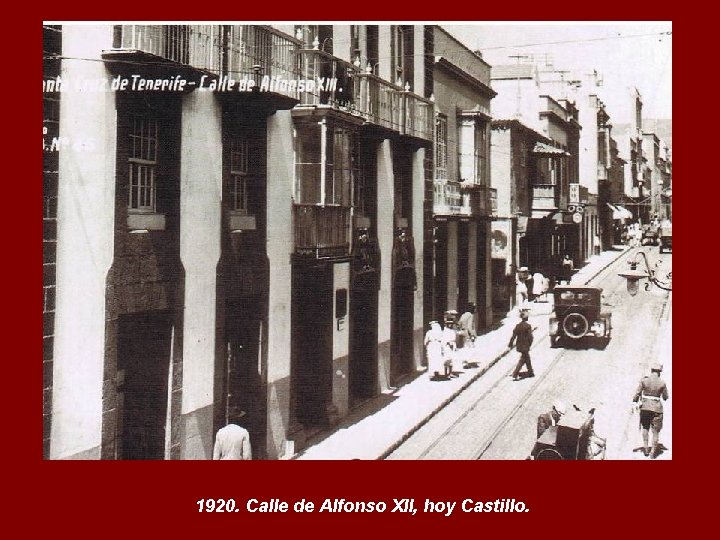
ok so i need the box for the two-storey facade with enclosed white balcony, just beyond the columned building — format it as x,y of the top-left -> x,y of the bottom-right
429,26 -> 496,327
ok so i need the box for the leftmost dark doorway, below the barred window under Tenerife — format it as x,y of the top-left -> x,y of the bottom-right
117,312 -> 172,459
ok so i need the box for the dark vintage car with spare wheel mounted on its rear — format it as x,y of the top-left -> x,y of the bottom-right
549,286 -> 612,347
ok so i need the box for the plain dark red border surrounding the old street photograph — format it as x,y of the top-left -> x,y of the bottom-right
26,8 -> 692,538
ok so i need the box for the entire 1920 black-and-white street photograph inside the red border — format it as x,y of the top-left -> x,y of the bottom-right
42,21 -> 675,460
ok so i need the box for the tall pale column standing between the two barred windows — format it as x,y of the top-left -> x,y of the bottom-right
180,91 -> 222,459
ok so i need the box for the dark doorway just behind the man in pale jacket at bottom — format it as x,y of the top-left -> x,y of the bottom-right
225,296 -> 266,456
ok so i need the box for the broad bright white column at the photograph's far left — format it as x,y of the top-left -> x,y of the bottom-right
50,25 -> 117,459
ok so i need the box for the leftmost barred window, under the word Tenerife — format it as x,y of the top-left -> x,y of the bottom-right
128,115 -> 158,213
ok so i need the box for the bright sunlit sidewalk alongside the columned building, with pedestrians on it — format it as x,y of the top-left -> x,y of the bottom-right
292,246 -> 626,460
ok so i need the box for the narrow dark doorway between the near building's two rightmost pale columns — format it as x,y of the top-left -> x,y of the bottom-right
390,269 -> 414,384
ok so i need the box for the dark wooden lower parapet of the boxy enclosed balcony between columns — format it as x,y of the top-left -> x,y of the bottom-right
293,204 -> 350,259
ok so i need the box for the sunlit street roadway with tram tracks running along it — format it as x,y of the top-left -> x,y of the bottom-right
388,246 -> 672,460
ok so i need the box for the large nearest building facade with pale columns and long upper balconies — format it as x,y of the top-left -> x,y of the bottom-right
44,25 -> 434,459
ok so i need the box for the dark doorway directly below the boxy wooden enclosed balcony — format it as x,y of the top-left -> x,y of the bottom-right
292,265 -> 333,426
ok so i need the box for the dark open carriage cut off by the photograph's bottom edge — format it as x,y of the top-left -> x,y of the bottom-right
530,409 -> 607,460
